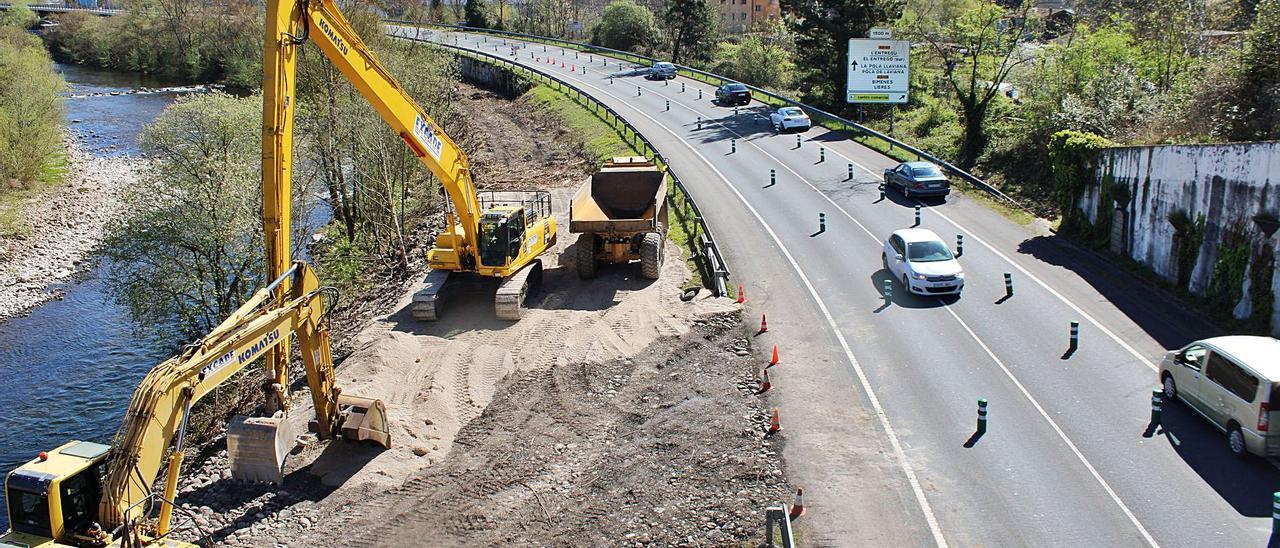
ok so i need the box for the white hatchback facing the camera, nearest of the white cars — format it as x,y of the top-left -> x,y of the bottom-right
881,228 -> 964,294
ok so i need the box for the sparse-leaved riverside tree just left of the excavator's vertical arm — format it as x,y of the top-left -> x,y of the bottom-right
102,92 -> 308,338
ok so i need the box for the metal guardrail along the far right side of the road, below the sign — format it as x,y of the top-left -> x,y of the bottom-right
387,19 -> 1030,211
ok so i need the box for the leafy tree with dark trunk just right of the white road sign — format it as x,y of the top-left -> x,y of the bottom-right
908,0 -> 1036,168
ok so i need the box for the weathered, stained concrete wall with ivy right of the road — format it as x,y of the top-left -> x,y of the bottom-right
1080,141 -> 1280,335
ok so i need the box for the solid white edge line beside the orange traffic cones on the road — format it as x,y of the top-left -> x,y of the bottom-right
424,33 -> 947,548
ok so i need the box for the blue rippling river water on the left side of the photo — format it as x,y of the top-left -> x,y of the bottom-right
0,65 -> 179,530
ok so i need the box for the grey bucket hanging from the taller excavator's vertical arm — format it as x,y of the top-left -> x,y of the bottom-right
227,414 -> 293,485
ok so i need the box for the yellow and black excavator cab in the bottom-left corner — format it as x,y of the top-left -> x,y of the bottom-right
0,442 -> 110,547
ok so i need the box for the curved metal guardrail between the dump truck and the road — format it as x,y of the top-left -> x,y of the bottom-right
390,28 -> 730,297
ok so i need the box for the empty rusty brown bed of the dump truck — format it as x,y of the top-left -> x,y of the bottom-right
568,163 -> 667,233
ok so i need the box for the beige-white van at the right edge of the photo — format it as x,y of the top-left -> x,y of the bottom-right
1160,335 -> 1280,456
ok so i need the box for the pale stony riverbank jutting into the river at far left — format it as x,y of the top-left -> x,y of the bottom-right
0,137 -> 146,321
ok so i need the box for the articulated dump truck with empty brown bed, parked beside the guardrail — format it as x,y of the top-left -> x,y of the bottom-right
568,156 -> 667,279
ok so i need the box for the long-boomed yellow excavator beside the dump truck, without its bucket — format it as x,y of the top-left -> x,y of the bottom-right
262,0 -> 556,320
